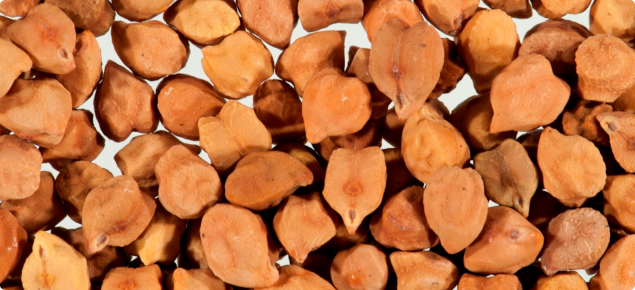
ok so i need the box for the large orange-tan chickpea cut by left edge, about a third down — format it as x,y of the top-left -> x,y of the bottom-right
0,79 -> 72,148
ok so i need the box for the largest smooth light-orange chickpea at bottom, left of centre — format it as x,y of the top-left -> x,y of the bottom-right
201,204 -> 279,288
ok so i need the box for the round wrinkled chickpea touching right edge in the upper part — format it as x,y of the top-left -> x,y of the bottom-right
575,34 -> 635,103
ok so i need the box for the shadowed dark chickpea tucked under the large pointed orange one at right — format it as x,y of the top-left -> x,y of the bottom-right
448,93 -> 520,152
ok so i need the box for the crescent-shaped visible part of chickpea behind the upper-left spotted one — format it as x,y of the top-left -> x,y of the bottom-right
57,30 -> 101,109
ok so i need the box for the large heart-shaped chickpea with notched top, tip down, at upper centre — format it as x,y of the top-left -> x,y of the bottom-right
368,19 -> 444,120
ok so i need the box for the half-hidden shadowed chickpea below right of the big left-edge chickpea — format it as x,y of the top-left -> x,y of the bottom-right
40,110 -> 105,170
